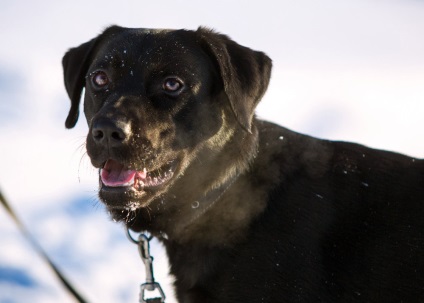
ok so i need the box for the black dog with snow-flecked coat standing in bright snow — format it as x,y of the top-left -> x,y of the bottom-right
63,27 -> 424,303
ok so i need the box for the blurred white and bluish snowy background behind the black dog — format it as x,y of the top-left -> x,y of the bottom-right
0,0 -> 424,303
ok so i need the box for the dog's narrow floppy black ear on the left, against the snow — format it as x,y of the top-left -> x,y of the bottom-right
62,38 -> 98,128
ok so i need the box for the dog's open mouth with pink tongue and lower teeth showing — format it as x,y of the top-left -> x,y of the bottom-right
100,159 -> 176,191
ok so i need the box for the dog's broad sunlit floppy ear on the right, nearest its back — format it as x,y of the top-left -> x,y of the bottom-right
197,27 -> 272,132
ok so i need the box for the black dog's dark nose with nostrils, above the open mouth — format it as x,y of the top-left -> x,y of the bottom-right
91,119 -> 130,147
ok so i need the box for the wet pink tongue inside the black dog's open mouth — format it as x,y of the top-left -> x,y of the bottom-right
100,160 -> 137,187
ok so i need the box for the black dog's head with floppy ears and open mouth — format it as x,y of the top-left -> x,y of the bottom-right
63,26 -> 271,230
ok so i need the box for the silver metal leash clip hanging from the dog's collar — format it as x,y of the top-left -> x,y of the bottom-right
127,228 -> 165,303
